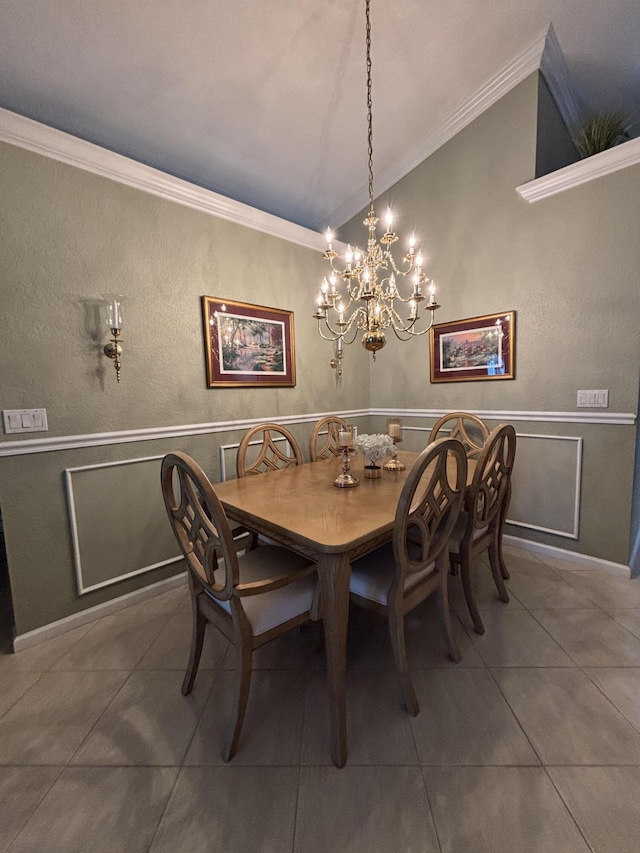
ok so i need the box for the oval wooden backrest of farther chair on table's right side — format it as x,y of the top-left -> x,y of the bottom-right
465,424 -> 516,536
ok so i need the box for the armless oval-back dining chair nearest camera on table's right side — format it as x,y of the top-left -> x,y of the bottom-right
349,438 -> 467,716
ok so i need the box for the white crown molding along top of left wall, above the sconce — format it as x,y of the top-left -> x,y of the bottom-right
0,108 -> 325,252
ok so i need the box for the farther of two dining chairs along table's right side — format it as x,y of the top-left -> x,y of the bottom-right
449,424 -> 516,634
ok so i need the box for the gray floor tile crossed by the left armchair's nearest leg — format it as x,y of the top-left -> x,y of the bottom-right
184,670 -> 307,766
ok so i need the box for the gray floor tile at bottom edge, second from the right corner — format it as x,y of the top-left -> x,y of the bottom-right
423,767 -> 589,853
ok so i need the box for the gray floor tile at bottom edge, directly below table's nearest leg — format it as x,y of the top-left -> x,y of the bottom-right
294,766 -> 438,853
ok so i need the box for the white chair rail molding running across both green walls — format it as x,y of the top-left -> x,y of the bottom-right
0,408 -> 636,458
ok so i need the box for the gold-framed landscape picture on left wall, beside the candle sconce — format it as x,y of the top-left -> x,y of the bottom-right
202,296 -> 296,388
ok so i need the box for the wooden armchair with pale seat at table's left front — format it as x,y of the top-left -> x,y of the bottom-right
162,453 -> 317,761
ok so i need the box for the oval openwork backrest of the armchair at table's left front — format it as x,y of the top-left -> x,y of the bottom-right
161,453 -> 239,601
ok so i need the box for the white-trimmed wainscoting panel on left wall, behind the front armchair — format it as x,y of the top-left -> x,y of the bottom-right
65,456 -> 182,595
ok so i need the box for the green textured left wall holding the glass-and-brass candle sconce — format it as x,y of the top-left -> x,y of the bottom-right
0,144 -> 369,633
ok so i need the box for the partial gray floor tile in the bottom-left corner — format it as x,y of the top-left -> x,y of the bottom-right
0,767 -> 60,853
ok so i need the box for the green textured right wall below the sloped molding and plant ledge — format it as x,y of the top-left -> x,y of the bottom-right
340,74 -> 640,563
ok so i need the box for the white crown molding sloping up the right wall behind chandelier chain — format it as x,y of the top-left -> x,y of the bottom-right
327,29 -> 548,225
